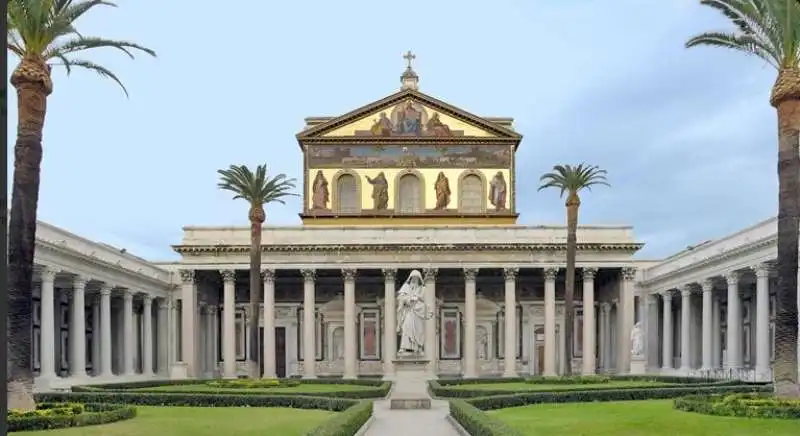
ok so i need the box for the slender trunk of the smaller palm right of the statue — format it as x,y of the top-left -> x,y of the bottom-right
563,192 -> 581,376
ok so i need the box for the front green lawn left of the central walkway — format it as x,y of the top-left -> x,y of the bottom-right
20,407 -> 336,436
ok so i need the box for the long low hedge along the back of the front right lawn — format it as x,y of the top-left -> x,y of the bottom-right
468,385 -> 772,410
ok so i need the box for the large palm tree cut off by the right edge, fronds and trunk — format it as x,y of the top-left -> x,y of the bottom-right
686,0 -> 800,398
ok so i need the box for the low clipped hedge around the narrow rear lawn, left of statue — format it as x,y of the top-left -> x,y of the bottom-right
72,378 -> 392,399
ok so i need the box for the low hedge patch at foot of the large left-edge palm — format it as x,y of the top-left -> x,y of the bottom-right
8,402 -> 136,432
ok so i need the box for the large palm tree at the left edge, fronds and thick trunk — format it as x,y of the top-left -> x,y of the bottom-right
6,0 -> 155,409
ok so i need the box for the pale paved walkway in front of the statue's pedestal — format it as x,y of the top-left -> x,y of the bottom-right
364,400 -> 458,436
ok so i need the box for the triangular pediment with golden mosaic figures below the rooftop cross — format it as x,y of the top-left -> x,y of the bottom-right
297,90 -> 521,140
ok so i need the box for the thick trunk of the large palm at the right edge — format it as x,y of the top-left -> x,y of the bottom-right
772,88 -> 800,398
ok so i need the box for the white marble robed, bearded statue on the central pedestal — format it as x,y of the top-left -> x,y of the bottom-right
397,270 -> 433,356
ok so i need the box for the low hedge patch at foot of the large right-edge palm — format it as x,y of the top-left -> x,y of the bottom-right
674,393 -> 800,419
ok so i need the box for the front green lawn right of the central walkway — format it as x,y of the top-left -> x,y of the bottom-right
487,400 -> 800,436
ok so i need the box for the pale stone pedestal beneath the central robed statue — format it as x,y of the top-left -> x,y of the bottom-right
389,358 -> 431,409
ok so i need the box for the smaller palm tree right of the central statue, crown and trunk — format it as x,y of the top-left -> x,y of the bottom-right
539,164 -> 611,375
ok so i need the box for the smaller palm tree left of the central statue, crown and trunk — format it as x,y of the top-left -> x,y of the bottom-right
217,165 -> 297,378
